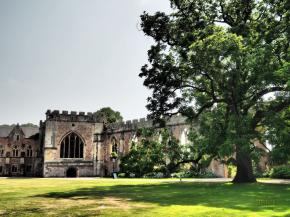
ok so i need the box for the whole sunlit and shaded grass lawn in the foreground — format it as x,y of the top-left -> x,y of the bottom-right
0,179 -> 290,217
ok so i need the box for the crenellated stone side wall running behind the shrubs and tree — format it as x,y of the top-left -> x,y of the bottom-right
100,116 -> 227,177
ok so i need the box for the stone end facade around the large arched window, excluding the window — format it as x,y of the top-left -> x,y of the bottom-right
41,111 -> 104,177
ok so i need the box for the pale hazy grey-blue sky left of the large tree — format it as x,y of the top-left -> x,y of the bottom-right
0,0 -> 170,124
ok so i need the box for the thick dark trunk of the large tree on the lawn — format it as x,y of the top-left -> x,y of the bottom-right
233,150 -> 256,183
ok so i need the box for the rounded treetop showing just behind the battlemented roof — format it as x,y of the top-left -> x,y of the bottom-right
94,107 -> 123,123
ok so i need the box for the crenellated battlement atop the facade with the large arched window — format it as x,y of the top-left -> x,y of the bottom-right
45,110 -> 102,123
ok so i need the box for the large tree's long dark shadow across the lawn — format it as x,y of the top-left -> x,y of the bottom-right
34,182 -> 290,212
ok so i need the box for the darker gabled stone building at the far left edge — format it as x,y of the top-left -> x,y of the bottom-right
0,125 -> 43,176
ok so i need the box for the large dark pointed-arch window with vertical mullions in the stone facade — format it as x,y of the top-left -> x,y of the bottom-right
60,132 -> 84,158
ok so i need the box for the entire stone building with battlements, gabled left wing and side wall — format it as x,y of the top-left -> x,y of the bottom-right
0,110 -> 227,177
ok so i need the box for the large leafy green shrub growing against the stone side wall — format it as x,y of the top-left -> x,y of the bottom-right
120,128 -> 207,177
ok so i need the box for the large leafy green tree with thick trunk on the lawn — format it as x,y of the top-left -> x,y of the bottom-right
140,0 -> 290,182
